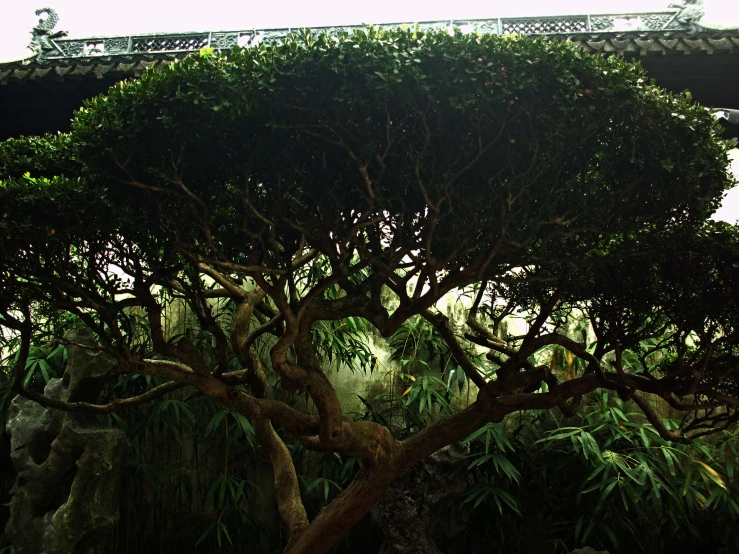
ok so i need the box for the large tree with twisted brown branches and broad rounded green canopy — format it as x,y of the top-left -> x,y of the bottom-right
0,28 -> 739,554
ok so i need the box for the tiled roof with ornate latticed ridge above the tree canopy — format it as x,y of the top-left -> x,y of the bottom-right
0,10 -> 739,84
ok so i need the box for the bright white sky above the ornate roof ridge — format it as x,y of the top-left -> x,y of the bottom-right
0,0 -> 739,223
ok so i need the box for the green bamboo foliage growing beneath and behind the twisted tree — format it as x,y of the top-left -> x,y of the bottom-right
0,319 -> 739,554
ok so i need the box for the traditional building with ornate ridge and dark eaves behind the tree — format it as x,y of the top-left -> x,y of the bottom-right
0,5 -> 739,139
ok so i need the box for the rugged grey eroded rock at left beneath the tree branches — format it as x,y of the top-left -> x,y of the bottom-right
6,334 -> 127,554
